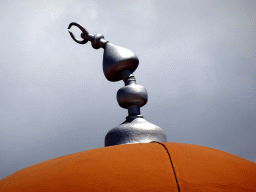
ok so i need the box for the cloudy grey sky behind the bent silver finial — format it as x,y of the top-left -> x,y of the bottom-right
0,0 -> 256,179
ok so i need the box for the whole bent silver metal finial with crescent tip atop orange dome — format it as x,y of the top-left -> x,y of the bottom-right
68,22 -> 167,146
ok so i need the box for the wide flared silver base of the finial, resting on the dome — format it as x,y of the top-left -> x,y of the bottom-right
105,115 -> 167,146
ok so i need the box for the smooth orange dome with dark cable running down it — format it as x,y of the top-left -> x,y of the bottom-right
0,142 -> 256,192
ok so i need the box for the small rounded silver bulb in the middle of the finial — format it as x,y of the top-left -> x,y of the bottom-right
117,84 -> 148,109
